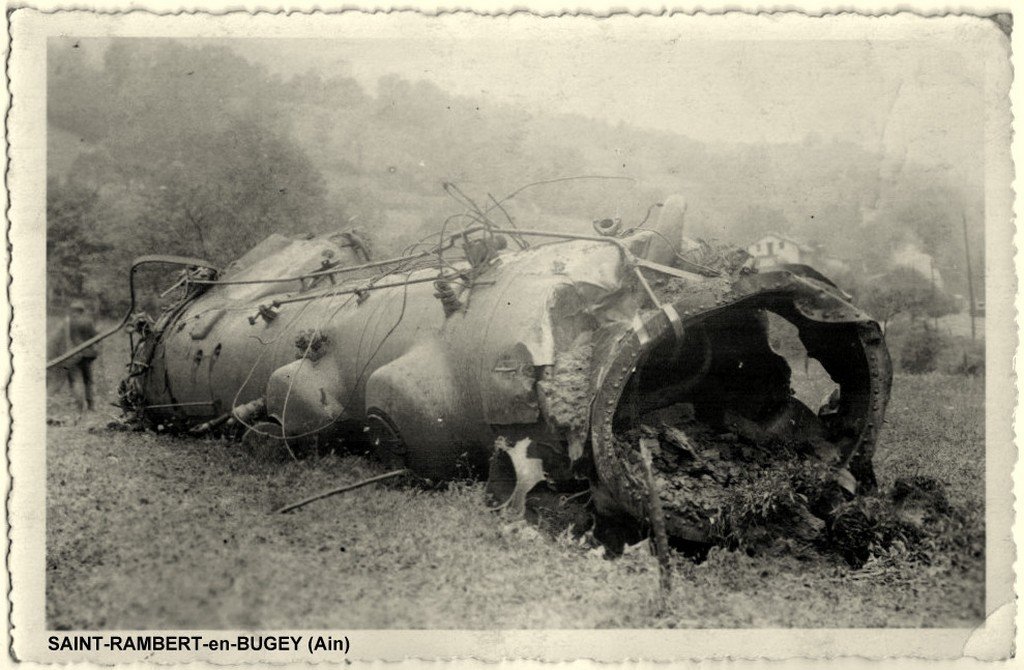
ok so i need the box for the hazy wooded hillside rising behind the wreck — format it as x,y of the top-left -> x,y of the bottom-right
47,39 -> 982,311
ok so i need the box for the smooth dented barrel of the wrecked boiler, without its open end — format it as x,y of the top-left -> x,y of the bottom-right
134,236 -> 642,476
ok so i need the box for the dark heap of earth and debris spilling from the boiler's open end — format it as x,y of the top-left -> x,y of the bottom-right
527,401 -> 985,569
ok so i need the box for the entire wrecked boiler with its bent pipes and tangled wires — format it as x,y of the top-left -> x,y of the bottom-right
48,179 -> 892,553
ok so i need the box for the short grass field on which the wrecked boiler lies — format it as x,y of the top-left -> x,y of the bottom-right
46,333 -> 985,629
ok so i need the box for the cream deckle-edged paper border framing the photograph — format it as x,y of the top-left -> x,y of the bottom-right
3,7 -> 1022,664
